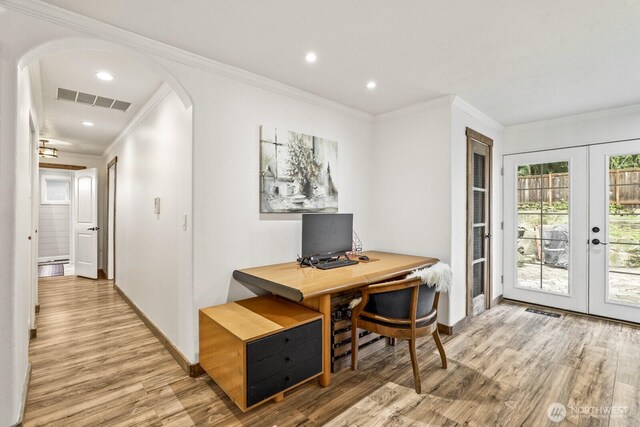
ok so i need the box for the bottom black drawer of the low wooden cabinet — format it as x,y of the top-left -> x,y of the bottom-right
247,355 -> 322,407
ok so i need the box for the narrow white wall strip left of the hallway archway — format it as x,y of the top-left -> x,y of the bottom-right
0,49 -> 35,425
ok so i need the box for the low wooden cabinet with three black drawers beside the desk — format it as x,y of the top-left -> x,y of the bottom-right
200,296 -> 323,411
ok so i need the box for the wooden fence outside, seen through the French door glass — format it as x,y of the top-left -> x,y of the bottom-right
518,169 -> 640,208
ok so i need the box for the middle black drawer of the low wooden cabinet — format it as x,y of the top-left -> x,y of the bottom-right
247,339 -> 322,386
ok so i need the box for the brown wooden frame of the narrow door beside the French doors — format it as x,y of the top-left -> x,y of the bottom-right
465,128 -> 493,318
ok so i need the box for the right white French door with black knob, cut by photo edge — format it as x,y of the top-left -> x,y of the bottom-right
589,140 -> 640,323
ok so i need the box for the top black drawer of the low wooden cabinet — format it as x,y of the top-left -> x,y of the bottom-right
247,320 -> 322,365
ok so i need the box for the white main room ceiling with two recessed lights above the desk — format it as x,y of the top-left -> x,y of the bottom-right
40,0 -> 640,125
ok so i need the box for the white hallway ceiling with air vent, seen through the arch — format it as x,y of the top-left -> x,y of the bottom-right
40,50 -> 162,155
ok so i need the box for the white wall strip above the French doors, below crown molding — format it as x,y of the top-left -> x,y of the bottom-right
504,105 -> 640,154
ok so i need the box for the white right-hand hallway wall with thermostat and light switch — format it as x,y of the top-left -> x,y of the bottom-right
102,86 -> 192,362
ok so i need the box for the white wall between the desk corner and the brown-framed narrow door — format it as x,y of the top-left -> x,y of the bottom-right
364,97 -> 451,324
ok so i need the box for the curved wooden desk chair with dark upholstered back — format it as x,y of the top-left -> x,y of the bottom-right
351,277 -> 447,394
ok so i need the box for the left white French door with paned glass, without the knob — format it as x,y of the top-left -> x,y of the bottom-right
504,147 -> 589,312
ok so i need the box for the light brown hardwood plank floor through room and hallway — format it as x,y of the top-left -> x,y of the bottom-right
24,277 -> 640,426
